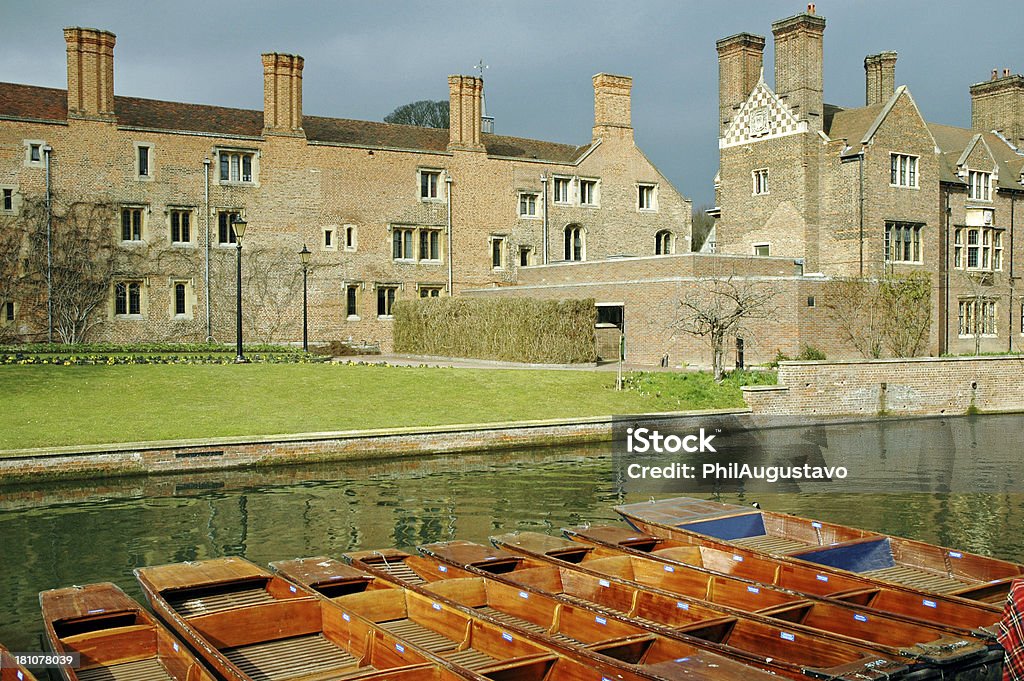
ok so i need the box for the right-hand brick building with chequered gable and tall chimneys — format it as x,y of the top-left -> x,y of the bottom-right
716,5 -> 1024,353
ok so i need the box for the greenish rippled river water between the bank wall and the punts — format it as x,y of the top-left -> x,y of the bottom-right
0,415 -> 1024,651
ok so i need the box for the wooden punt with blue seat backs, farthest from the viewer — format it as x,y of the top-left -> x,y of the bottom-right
615,497 -> 1024,603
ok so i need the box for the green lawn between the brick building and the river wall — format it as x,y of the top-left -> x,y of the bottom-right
0,364 -> 770,450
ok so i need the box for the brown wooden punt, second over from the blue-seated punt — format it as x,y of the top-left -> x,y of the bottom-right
492,533 -> 1001,678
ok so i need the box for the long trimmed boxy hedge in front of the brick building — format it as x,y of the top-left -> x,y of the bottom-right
394,298 -> 597,365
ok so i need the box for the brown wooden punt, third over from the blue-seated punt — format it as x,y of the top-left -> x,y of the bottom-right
362,541 -> 908,681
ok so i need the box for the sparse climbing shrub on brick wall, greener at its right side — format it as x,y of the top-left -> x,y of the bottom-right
823,272 -> 932,358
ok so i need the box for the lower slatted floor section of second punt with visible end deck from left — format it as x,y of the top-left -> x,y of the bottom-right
223,634 -> 358,681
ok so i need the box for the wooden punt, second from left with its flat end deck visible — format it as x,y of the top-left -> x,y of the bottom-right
135,557 -> 468,681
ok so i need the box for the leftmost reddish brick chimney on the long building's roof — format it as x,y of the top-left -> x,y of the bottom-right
65,27 -> 116,121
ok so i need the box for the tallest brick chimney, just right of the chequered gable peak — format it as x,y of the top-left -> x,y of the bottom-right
771,5 -> 825,131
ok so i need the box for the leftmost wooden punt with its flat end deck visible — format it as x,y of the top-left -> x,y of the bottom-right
39,583 -> 215,681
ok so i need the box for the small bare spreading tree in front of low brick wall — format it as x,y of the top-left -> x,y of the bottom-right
676,276 -> 778,382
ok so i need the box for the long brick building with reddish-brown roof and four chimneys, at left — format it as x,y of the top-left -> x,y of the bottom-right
0,28 -> 690,349
